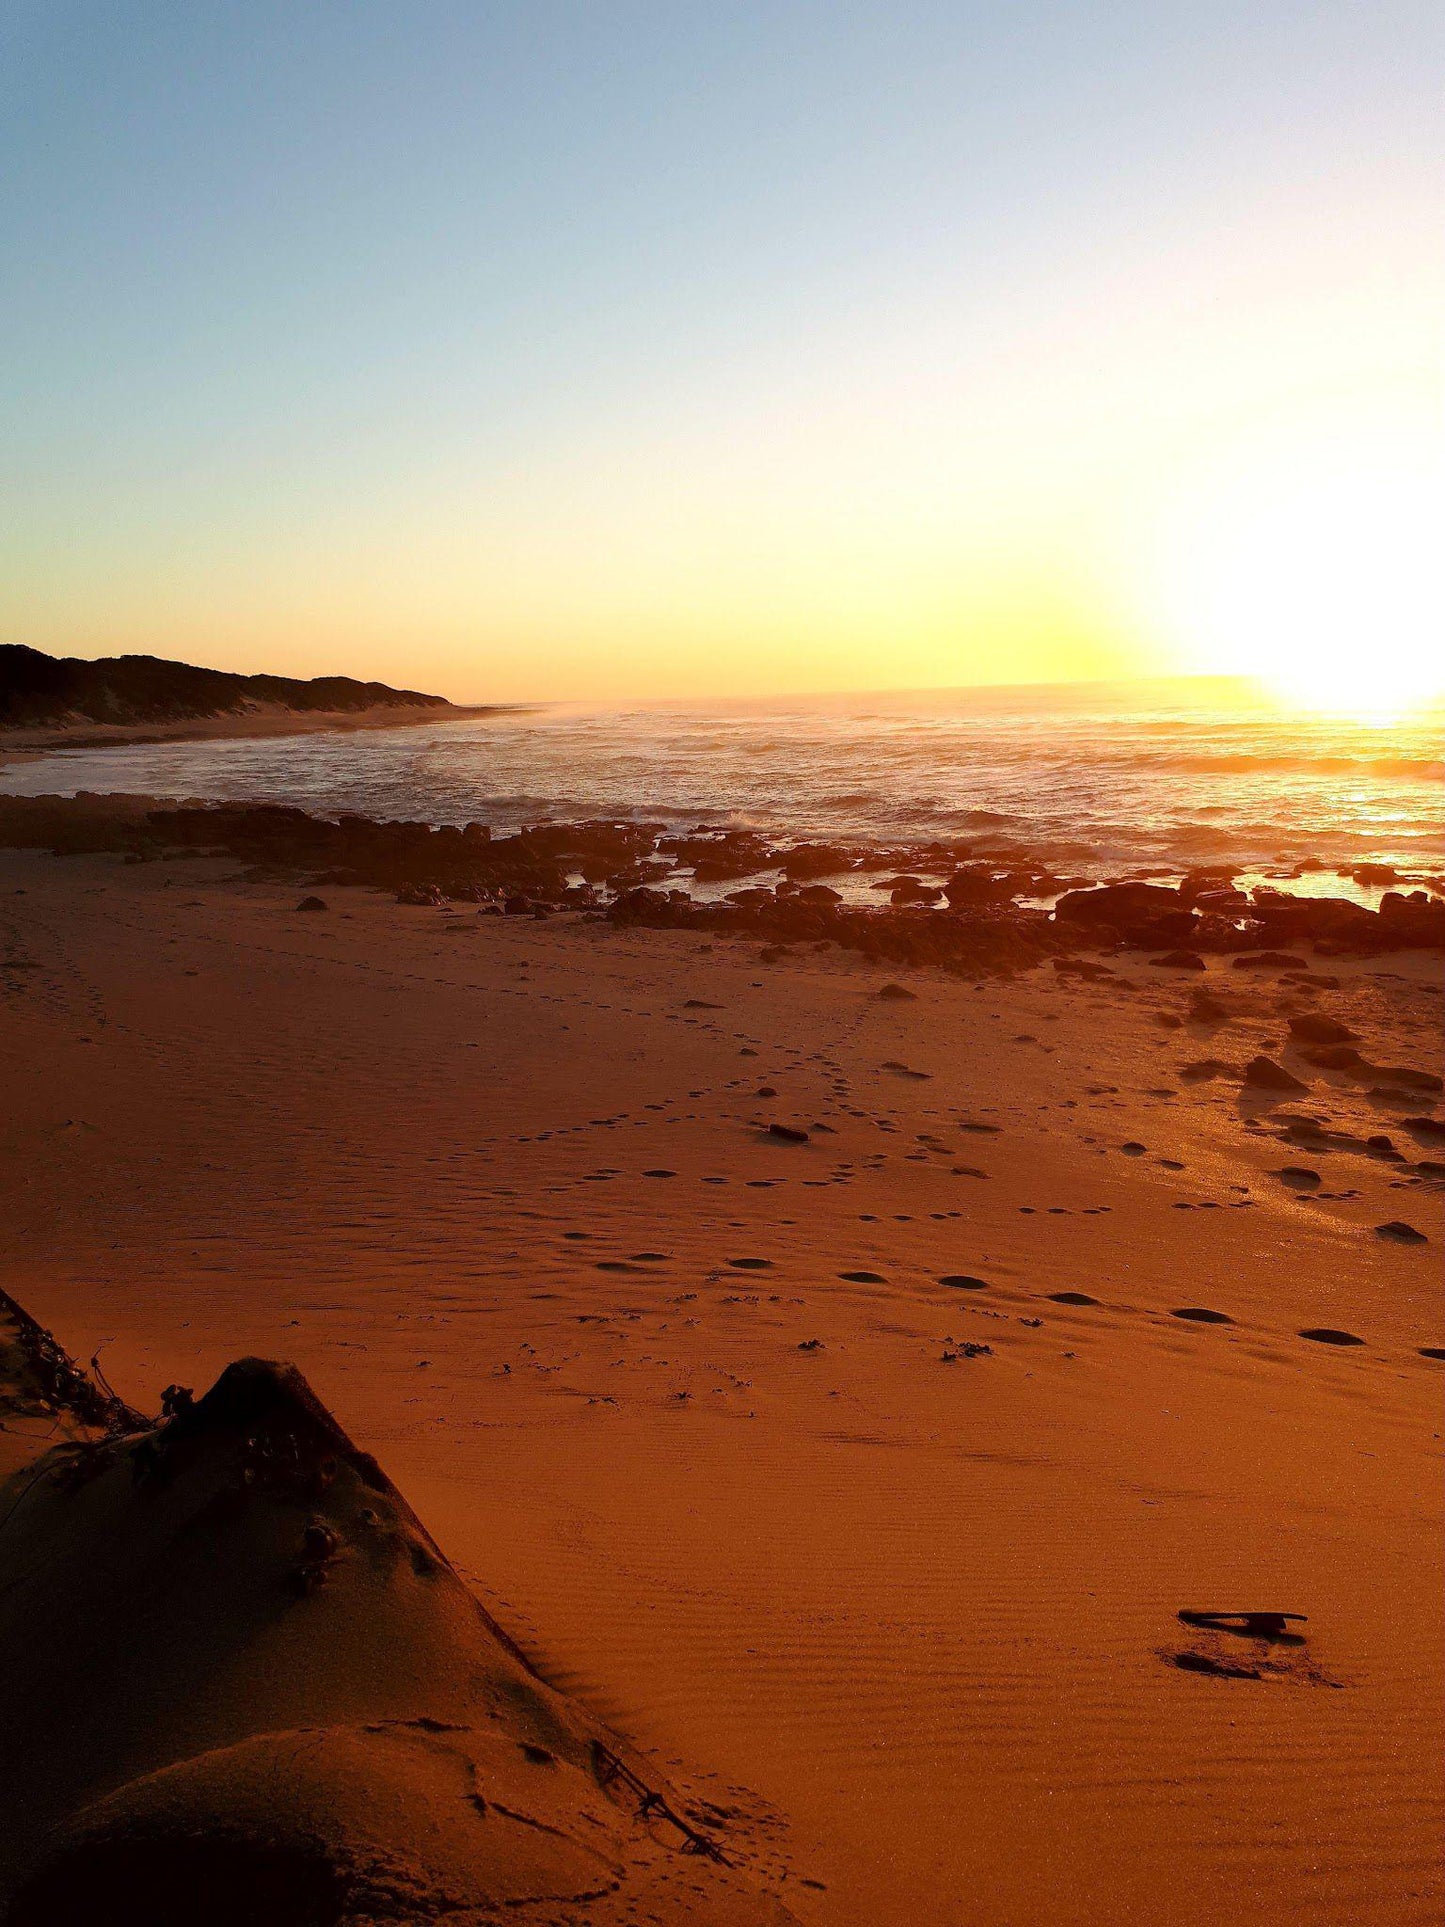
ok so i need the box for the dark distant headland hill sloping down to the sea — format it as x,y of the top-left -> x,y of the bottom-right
0,642 -> 451,728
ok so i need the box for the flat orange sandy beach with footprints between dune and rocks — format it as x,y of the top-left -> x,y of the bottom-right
0,836 -> 1445,1927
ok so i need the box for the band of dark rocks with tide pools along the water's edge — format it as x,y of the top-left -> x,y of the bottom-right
0,792 -> 1445,971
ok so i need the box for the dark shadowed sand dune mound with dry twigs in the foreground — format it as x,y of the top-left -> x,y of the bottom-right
0,1312 -> 786,1927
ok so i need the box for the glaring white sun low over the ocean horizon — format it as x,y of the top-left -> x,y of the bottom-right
1162,423 -> 1445,721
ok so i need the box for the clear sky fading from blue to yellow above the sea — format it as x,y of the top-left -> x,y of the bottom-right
0,0 -> 1445,705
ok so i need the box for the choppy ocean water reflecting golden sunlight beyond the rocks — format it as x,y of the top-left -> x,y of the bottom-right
0,686 -> 1445,894
